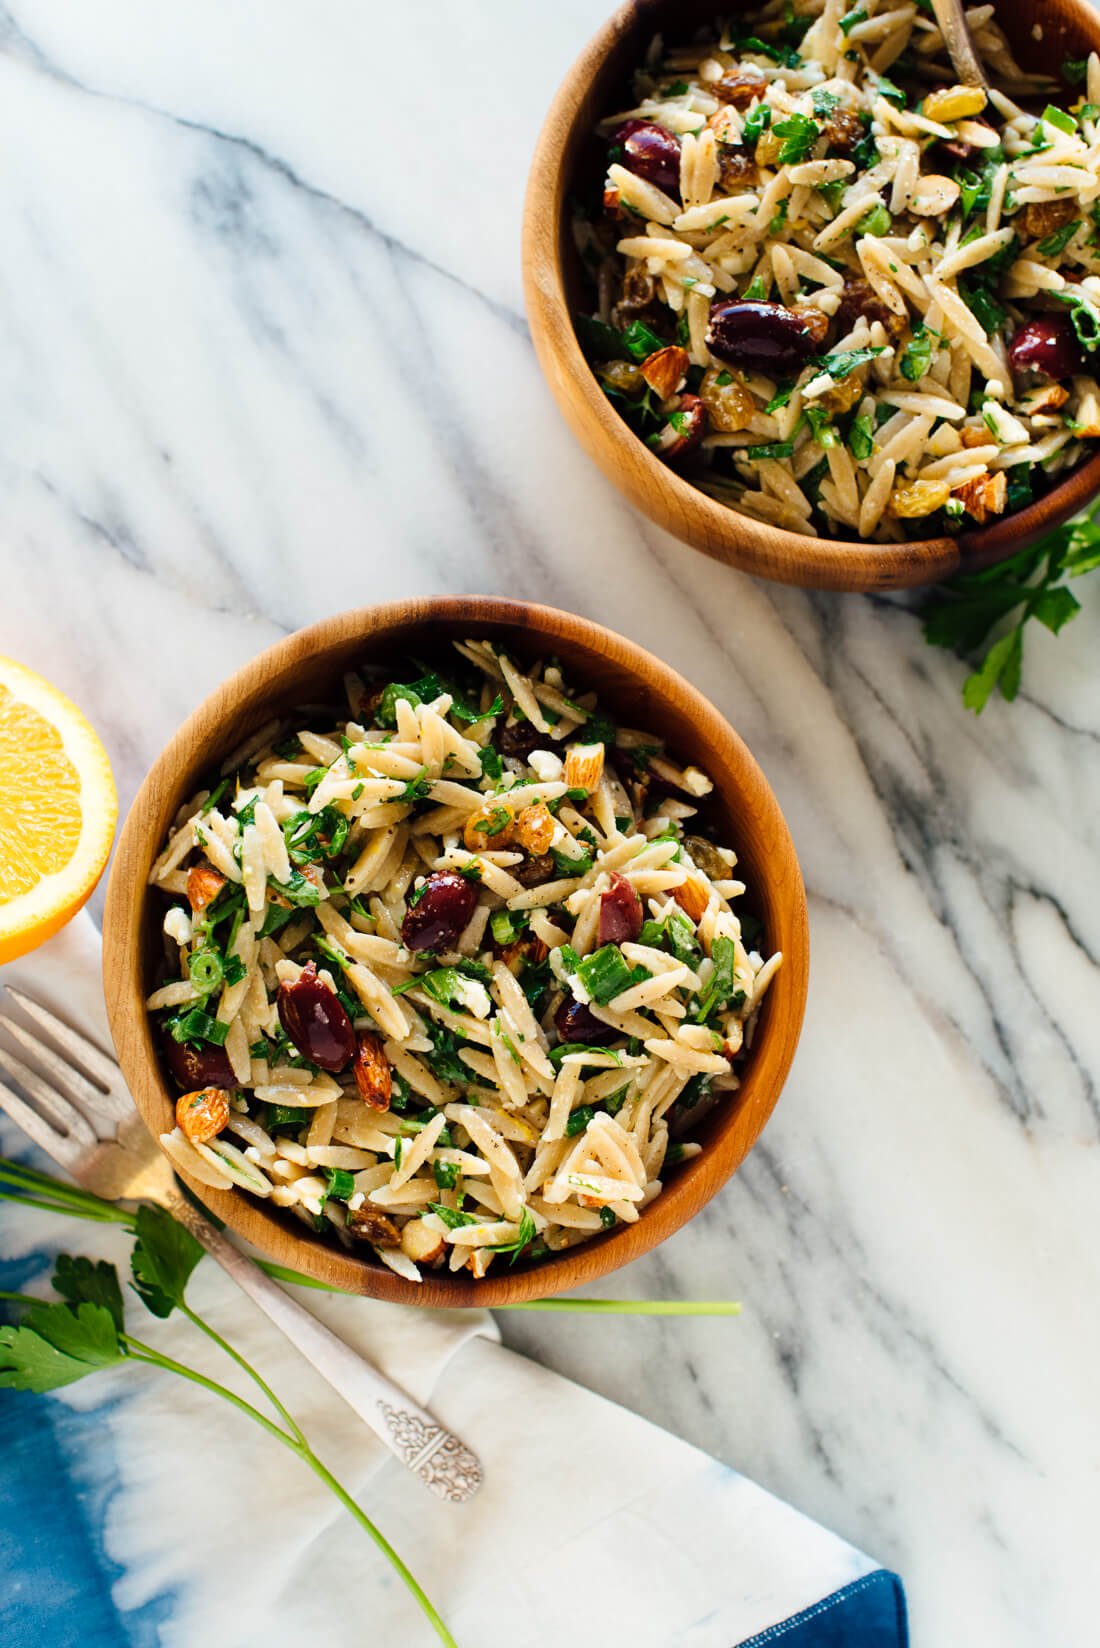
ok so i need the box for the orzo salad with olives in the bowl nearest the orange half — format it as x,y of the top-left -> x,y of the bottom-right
148,641 -> 782,1280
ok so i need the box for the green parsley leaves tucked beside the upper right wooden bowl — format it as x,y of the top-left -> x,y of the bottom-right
922,499 -> 1100,714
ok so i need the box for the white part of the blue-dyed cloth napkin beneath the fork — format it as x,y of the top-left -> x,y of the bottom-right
0,916 -> 877,1648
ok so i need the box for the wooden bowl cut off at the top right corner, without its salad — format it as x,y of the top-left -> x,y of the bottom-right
523,0 -> 1100,590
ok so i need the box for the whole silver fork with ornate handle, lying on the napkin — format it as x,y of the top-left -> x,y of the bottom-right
0,984 -> 482,1503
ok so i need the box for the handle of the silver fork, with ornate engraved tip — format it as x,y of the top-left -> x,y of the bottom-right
158,1192 -> 482,1505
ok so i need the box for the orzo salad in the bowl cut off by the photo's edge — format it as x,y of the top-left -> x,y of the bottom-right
576,0 -> 1100,541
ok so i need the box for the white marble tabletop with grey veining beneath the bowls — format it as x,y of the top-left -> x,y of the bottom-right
0,0 -> 1100,1648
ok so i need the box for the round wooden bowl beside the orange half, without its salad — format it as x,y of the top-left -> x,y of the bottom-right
104,597 -> 808,1305
